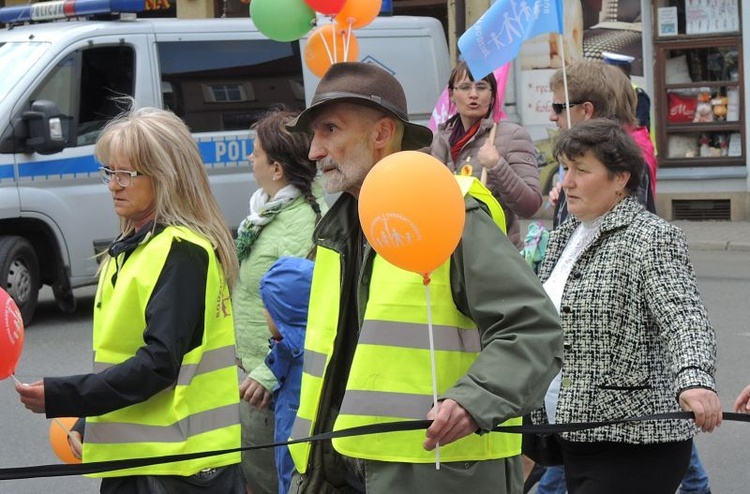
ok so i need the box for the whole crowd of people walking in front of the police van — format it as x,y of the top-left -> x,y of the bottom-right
10,57 -> 750,494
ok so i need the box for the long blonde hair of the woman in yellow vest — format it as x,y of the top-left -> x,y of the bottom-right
94,108 -> 239,287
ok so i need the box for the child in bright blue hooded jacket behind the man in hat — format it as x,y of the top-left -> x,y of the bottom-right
260,257 -> 313,494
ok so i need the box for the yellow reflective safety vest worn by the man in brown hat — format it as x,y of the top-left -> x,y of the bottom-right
289,176 -> 520,466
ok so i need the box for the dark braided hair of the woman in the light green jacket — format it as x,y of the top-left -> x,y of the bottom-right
252,109 -> 320,219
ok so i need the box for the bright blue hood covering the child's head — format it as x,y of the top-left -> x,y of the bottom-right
260,257 -> 313,339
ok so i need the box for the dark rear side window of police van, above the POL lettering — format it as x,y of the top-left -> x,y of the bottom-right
157,40 -> 305,132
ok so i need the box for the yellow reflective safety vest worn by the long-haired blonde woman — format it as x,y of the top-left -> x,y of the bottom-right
88,227 -> 240,477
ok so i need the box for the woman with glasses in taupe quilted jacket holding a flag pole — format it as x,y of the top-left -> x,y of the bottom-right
430,61 -> 542,250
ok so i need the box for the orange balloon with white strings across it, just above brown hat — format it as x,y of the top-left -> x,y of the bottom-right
305,24 -> 359,77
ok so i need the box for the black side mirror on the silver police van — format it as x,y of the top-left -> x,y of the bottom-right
21,100 -> 68,154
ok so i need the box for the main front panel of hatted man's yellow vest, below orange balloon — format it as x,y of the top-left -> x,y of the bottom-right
333,256 -> 521,463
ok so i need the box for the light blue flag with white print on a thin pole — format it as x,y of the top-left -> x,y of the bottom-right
458,0 -> 563,80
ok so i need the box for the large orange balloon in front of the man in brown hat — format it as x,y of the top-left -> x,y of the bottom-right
359,151 -> 466,277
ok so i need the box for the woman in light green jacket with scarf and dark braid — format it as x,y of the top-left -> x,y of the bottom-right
232,111 -> 328,494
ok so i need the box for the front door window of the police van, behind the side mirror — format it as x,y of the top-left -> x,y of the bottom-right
31,45 -> 135,147
